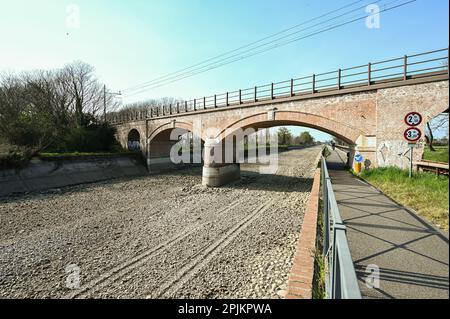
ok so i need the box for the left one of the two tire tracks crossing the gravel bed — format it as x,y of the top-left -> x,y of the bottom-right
62,202 -> 241,299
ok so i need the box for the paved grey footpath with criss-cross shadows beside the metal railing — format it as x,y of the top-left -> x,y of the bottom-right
327,151 -> 449,299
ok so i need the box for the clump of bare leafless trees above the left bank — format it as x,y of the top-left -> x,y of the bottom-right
0,62 -> 117,153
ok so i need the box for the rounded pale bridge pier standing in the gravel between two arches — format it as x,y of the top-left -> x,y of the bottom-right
202,139 -> 241,187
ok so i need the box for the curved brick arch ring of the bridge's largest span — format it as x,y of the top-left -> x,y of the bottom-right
213,110 -> 366,145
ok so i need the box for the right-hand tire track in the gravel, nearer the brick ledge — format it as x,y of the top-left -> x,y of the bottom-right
147,200 -> 274,299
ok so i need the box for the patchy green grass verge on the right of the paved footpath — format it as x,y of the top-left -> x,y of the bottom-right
360,167 -> 449,230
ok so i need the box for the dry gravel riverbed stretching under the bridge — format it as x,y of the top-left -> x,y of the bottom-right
0,147 -> 321,298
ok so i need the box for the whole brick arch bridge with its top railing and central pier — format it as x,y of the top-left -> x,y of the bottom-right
109,49 -> 449,186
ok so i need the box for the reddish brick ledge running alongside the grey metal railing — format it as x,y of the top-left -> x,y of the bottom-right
286,169 -> 320,299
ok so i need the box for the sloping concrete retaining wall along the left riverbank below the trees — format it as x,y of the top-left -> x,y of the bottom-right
0,155 -> 148,197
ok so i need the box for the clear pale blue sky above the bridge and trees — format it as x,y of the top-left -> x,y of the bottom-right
0,0 -> 449,139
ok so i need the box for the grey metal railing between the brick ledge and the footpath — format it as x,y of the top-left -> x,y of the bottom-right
321,157 -> 362,299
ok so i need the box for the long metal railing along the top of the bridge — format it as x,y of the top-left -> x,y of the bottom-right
108,48 -> 449,123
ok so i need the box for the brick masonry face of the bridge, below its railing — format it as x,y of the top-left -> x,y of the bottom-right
117,77 -> 449,172
